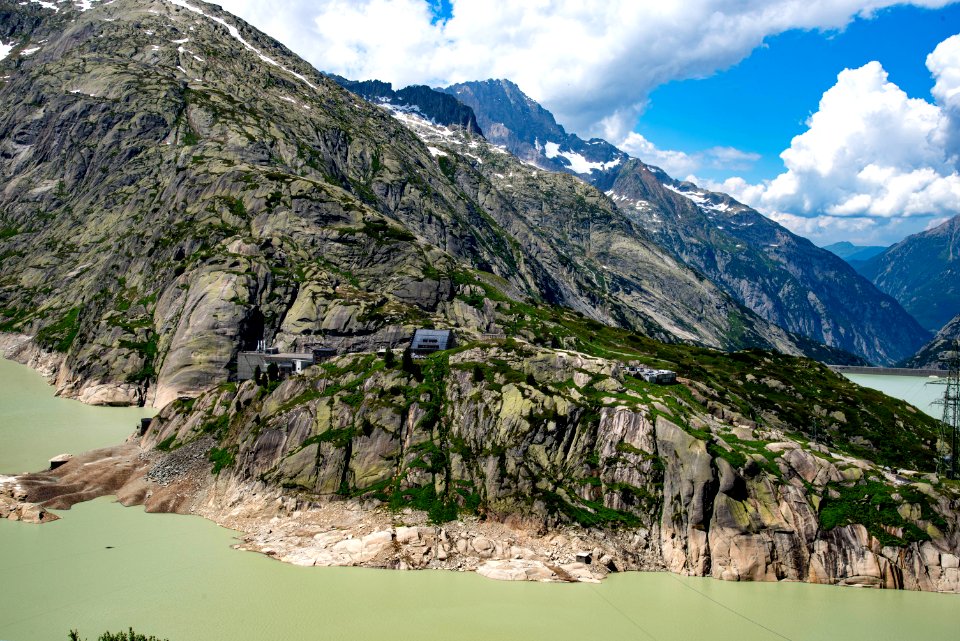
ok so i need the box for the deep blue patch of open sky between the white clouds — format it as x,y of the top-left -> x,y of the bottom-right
635,5 -> 960,182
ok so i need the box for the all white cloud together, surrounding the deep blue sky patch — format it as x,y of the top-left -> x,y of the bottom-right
214,0 -> 960,243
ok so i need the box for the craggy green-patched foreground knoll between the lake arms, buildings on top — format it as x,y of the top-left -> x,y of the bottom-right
17,307 -> 960,591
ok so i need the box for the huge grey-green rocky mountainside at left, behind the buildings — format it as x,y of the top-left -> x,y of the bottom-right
0,0 -> 815,406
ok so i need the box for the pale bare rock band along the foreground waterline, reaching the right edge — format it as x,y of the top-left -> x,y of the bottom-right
7,416 -> 960,593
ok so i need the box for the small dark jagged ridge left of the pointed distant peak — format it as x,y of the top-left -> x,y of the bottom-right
329,74 -> 483,136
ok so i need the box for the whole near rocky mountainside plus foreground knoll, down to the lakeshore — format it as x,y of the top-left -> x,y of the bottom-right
0,0 -> 960,591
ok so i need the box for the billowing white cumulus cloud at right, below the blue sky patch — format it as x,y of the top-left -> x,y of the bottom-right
705,36 -> 960,240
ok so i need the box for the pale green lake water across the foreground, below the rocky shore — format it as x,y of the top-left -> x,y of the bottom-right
0,364 -> 960,641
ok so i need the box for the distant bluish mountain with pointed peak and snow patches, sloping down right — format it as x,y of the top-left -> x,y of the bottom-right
443,80 -> 930,364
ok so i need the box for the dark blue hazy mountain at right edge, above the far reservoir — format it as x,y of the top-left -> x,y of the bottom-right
858,216 -> 960,332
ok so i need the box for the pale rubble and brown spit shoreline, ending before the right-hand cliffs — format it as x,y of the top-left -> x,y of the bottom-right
0,440 -> 663,582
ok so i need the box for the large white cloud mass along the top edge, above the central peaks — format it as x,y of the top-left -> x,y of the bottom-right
216,0 -> 951,140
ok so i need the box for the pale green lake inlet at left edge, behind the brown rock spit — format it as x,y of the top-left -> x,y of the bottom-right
0,358 -> 154,474
